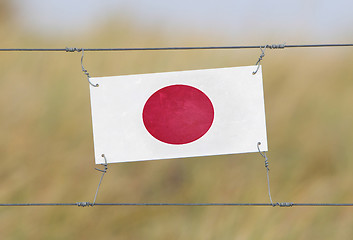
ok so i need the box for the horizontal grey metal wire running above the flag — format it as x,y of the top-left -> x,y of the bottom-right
0,43 -> 353,52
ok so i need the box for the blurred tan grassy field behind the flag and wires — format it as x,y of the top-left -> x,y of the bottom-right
0,1 -> 353,239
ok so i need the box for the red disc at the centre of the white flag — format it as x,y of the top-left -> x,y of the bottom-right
142,85 -> 214,144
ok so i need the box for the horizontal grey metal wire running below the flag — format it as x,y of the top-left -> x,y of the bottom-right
0,202 -> 353,207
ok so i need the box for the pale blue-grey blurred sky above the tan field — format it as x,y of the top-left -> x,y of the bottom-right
12,0 -> 353,43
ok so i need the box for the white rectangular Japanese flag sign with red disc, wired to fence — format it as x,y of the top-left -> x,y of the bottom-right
90,66 -> 267,164
